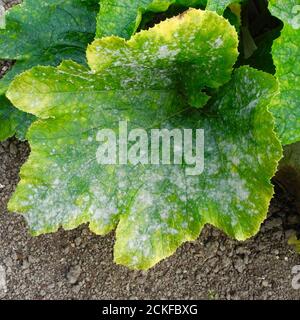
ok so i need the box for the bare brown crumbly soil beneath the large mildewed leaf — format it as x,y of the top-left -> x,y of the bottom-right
0,1 -> 300,300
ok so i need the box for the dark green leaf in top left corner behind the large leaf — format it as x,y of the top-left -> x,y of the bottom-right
0,0 -> 99,140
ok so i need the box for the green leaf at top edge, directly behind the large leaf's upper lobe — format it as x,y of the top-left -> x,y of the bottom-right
96,0 -> 207,39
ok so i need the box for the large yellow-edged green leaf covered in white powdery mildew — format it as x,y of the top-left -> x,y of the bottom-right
8,10 -> 281,269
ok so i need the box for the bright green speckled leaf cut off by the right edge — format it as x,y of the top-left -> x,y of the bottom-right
269,0 -> 300,145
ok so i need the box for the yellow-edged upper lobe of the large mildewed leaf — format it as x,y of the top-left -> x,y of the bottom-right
87,10 -> 237,107
